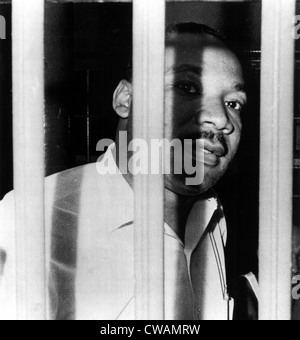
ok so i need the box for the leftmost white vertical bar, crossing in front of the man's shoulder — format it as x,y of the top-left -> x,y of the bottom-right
12,0 -> 46,320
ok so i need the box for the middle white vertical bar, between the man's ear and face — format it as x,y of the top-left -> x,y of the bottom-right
133,0 -> 165,320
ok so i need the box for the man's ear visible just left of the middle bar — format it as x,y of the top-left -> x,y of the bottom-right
113,80 -> 132,118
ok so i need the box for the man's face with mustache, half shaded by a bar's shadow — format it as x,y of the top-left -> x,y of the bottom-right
165,34 -> 247,196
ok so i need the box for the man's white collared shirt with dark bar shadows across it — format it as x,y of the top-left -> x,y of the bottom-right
0,145 -> 232,320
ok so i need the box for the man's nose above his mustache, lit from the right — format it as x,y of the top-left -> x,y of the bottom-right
195,101 -> 234,135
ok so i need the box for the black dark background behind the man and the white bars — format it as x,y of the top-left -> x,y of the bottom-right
0,0 -> 300,300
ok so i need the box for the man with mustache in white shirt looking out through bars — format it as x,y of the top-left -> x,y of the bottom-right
0,23 -> 247,320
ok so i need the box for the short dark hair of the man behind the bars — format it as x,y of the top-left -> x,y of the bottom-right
127,22 -> 230,81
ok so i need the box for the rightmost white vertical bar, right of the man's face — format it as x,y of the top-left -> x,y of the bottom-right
259,0 -> 295,320
